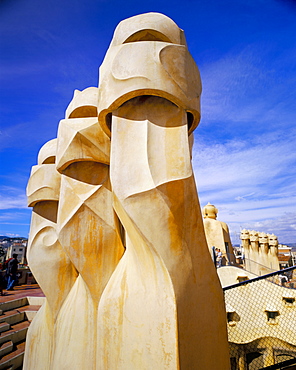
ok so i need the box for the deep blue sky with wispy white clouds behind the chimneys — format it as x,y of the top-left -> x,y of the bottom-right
0,0 -> 296,244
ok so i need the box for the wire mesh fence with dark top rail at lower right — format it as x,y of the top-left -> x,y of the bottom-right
223,266 -> 296,370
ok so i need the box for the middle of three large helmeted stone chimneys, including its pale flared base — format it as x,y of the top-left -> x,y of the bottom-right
53,89 -> 124,369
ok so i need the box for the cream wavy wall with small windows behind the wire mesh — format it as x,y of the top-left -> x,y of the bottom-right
221,278 -> 296,366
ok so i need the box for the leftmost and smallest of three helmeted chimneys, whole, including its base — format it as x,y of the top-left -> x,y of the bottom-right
23,140 -> 77,369
